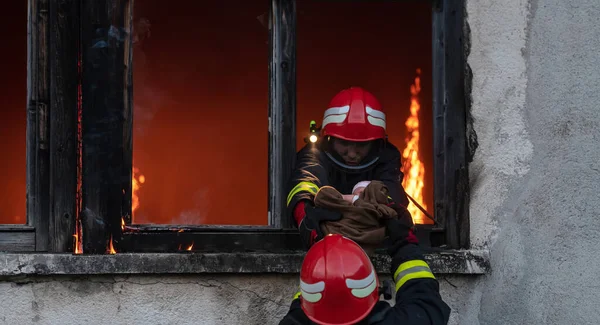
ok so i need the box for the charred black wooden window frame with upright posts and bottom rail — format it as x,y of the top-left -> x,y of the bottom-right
0,0 -> 470,254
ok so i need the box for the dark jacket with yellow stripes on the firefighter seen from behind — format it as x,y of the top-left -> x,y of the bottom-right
279,244 -> 450,325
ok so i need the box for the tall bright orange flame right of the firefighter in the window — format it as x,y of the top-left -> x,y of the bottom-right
402,69 -> 433,224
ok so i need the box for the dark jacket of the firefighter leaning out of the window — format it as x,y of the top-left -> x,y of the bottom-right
287,142 -> 408,225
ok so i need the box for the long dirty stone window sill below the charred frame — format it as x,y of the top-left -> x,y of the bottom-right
0,250 -> 490,276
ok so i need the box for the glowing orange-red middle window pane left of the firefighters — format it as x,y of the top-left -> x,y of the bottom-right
132,0 -> 269,225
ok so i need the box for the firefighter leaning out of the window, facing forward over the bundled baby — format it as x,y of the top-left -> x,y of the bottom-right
287,87 -> 408,248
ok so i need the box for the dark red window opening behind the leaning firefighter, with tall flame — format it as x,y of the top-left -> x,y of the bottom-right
296,0 -> 433,223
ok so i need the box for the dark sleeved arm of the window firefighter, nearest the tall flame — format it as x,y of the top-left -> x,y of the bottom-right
373,147 -> 408,207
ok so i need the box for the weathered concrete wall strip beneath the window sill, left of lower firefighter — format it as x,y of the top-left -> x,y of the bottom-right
0,274 -> 462,325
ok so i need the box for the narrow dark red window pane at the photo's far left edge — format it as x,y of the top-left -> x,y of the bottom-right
0,1 -> 27,224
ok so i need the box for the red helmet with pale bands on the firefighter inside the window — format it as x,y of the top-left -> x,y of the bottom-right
321,87 -> 385,141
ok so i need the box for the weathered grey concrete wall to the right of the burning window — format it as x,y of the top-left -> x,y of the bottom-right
462,0 -> 600,324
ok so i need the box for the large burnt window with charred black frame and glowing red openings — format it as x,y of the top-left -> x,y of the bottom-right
0,0 -> 468,254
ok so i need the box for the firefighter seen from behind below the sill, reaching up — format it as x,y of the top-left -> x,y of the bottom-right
279,205 -> 450,325
